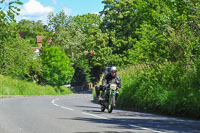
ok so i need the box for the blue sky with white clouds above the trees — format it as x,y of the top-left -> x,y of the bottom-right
16,0 -> 104,22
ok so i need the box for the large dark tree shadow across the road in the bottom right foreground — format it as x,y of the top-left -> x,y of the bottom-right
70,117 -> 200,133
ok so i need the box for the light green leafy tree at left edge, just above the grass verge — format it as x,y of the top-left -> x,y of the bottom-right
1,31 -> 40,80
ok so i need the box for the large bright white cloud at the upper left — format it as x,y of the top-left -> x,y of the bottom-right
20,0 -> 54,16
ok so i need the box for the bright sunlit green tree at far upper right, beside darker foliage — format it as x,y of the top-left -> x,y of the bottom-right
129,0 -> 200,62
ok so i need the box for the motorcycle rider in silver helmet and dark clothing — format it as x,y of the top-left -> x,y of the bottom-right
95,66 -> 121,103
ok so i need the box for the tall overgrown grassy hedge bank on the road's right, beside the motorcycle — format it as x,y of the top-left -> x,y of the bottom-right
117,62 -> 200,118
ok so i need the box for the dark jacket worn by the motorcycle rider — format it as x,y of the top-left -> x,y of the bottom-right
102,73 -> 121,88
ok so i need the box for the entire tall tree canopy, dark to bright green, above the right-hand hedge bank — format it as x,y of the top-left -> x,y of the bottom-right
101,0 -> 200,63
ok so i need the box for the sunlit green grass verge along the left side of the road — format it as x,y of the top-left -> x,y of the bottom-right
0,75 -> 73,96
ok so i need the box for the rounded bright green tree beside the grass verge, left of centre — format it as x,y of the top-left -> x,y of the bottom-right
41,47 -> 74,87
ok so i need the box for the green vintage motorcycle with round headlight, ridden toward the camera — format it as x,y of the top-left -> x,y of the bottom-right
100,84 -> 117,113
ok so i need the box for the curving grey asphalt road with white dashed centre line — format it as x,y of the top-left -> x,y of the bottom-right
0,92 -> 200,133
